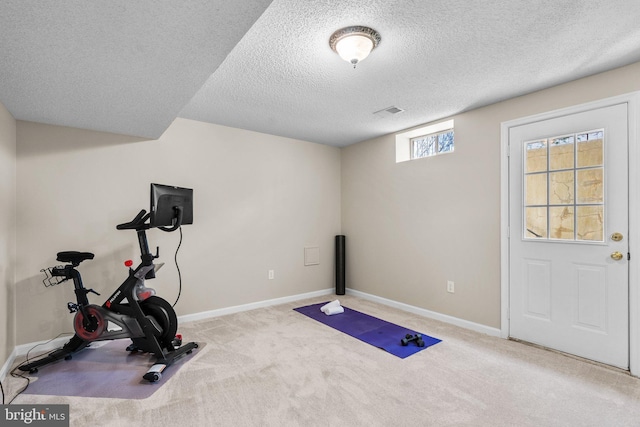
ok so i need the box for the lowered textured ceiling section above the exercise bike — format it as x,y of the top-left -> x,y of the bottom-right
0,0 -> 271,138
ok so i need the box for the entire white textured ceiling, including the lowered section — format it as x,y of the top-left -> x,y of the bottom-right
0,0 -> 640,146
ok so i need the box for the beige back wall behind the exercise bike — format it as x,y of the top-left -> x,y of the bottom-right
15,119 -> 340,344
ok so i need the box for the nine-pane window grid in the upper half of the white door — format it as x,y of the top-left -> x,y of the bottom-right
523,129 -> 604,242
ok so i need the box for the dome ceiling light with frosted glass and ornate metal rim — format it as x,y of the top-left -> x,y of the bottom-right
329,26 -> 380,68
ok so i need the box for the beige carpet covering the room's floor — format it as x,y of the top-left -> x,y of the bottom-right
5,296 -> 640,426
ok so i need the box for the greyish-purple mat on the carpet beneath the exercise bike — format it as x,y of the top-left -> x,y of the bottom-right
24,339 -> 204,399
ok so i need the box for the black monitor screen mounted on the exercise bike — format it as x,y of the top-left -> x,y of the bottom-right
149,184 -> 193,229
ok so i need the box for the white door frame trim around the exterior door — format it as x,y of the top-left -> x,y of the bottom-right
500,91 -> 640,377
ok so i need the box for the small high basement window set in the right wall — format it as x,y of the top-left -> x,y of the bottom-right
396,120 -> 455,163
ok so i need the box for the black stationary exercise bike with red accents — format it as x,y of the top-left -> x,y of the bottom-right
19,184 -> 198,382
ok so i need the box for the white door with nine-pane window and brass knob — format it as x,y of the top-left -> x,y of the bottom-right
509,103 -> 629,369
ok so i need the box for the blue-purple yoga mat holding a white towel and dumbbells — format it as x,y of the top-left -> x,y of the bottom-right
294,302 -> 442,359
